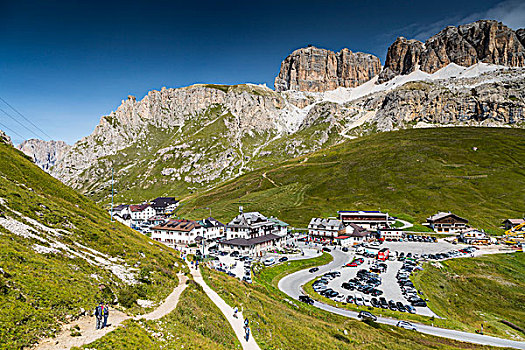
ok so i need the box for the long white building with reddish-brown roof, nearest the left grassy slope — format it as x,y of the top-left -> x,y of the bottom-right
150,219 -> 204,248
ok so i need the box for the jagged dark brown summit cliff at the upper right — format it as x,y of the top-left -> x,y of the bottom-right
378,20 -> 525,83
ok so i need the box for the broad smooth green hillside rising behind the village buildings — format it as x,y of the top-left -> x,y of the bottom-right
181,127 -> 525,230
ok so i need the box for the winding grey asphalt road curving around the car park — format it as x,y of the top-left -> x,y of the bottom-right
279,250 -> 525,349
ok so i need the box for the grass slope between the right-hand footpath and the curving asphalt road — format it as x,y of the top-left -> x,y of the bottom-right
201,255 -> 498,350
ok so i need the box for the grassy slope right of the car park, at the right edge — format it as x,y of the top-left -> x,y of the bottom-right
413,253 -> 525,340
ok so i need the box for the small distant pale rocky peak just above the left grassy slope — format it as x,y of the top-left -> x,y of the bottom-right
17,139 -> 71,171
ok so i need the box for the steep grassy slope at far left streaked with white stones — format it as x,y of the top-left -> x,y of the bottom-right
0,142 -> 181,348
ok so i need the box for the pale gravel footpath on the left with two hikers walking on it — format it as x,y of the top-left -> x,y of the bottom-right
34,274 -> 188,350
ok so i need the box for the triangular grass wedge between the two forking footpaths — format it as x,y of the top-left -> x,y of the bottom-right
77,280 -> 241,350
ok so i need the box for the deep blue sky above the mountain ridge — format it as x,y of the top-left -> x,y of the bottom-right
0,0 -> 525,143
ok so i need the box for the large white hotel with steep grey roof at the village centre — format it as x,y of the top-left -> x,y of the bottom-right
219,208 -> 284,256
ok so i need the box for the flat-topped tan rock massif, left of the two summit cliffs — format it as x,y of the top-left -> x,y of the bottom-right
275,46 -> 381,92
